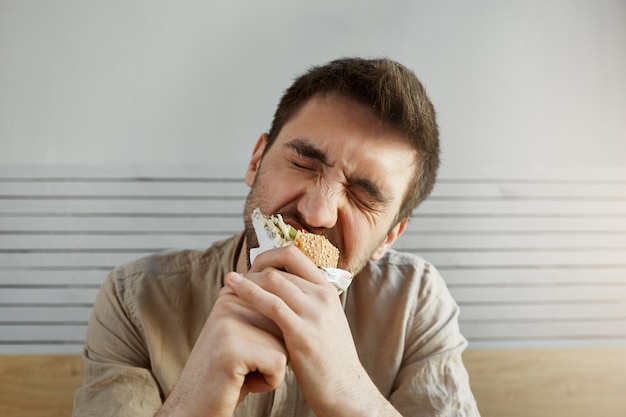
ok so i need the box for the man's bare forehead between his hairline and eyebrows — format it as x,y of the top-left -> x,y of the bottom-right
273,95 -> 417,195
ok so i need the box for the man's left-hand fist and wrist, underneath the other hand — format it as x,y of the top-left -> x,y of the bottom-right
157,289 -> 288,417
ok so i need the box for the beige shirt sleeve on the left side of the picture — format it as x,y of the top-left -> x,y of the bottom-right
73,269 -> 162,417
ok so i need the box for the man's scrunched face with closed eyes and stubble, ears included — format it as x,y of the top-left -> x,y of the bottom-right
244,95 -> 416,274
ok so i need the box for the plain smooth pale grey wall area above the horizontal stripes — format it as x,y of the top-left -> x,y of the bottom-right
0,0 -> 626,170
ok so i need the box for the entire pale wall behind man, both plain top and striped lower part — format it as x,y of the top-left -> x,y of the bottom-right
0,0 -> 626,353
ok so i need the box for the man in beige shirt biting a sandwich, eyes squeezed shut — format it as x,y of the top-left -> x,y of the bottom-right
74,58 -> 478,417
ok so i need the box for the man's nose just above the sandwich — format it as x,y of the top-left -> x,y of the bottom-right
298,184 -> 341,229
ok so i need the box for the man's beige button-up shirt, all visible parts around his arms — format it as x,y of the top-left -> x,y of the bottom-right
74,235 -> 479,417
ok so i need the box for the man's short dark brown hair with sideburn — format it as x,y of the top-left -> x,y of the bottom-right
266,58 -> 439,220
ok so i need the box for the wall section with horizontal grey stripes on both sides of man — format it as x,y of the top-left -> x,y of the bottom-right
0,167 -> 626,353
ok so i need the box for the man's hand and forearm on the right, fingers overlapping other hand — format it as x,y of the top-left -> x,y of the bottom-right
226,246 -> 398,416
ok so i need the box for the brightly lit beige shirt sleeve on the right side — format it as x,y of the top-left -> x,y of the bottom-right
390,264 -> 480,417
